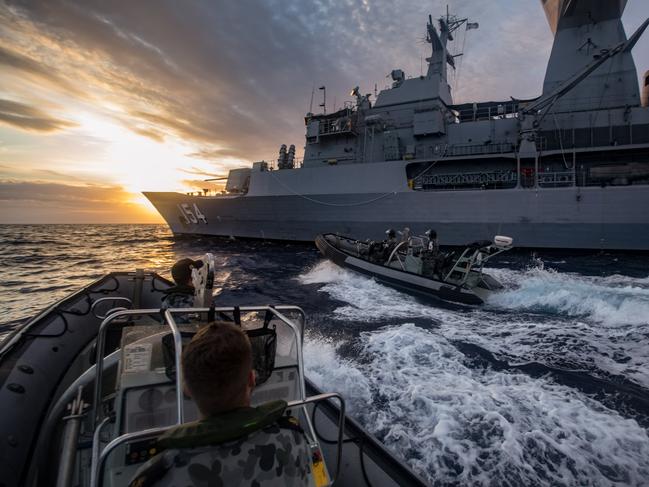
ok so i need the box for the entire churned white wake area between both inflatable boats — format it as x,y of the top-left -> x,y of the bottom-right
298,261 -> 649,485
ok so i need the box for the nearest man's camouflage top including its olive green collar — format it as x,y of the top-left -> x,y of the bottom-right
130,401 -> 315,487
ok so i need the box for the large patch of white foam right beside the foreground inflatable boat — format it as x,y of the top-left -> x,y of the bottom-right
307,324 -> 649,485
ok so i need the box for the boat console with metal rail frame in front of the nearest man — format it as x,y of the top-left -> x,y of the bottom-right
90,306 -> 344,487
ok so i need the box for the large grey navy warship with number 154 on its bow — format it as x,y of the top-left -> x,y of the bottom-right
144,0 -> 649,250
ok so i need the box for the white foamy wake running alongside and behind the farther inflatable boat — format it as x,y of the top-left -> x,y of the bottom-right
299,261 -> 649,387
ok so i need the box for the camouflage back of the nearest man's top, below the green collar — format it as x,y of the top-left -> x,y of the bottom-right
130,408 -> 315,487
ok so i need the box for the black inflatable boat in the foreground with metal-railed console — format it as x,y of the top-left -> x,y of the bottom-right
0,259 -> 426,487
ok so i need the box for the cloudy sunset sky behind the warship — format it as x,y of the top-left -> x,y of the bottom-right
0,0 -> 649,223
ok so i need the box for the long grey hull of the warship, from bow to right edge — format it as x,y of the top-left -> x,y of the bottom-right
145,177 -> 649,250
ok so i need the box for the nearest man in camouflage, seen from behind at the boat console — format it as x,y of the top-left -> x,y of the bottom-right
130,323 -> 315,487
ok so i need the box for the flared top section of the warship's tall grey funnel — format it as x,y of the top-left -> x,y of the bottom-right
541,0 -> 627,34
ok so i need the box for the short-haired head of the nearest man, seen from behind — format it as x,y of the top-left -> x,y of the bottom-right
182,322 -> 255,417
